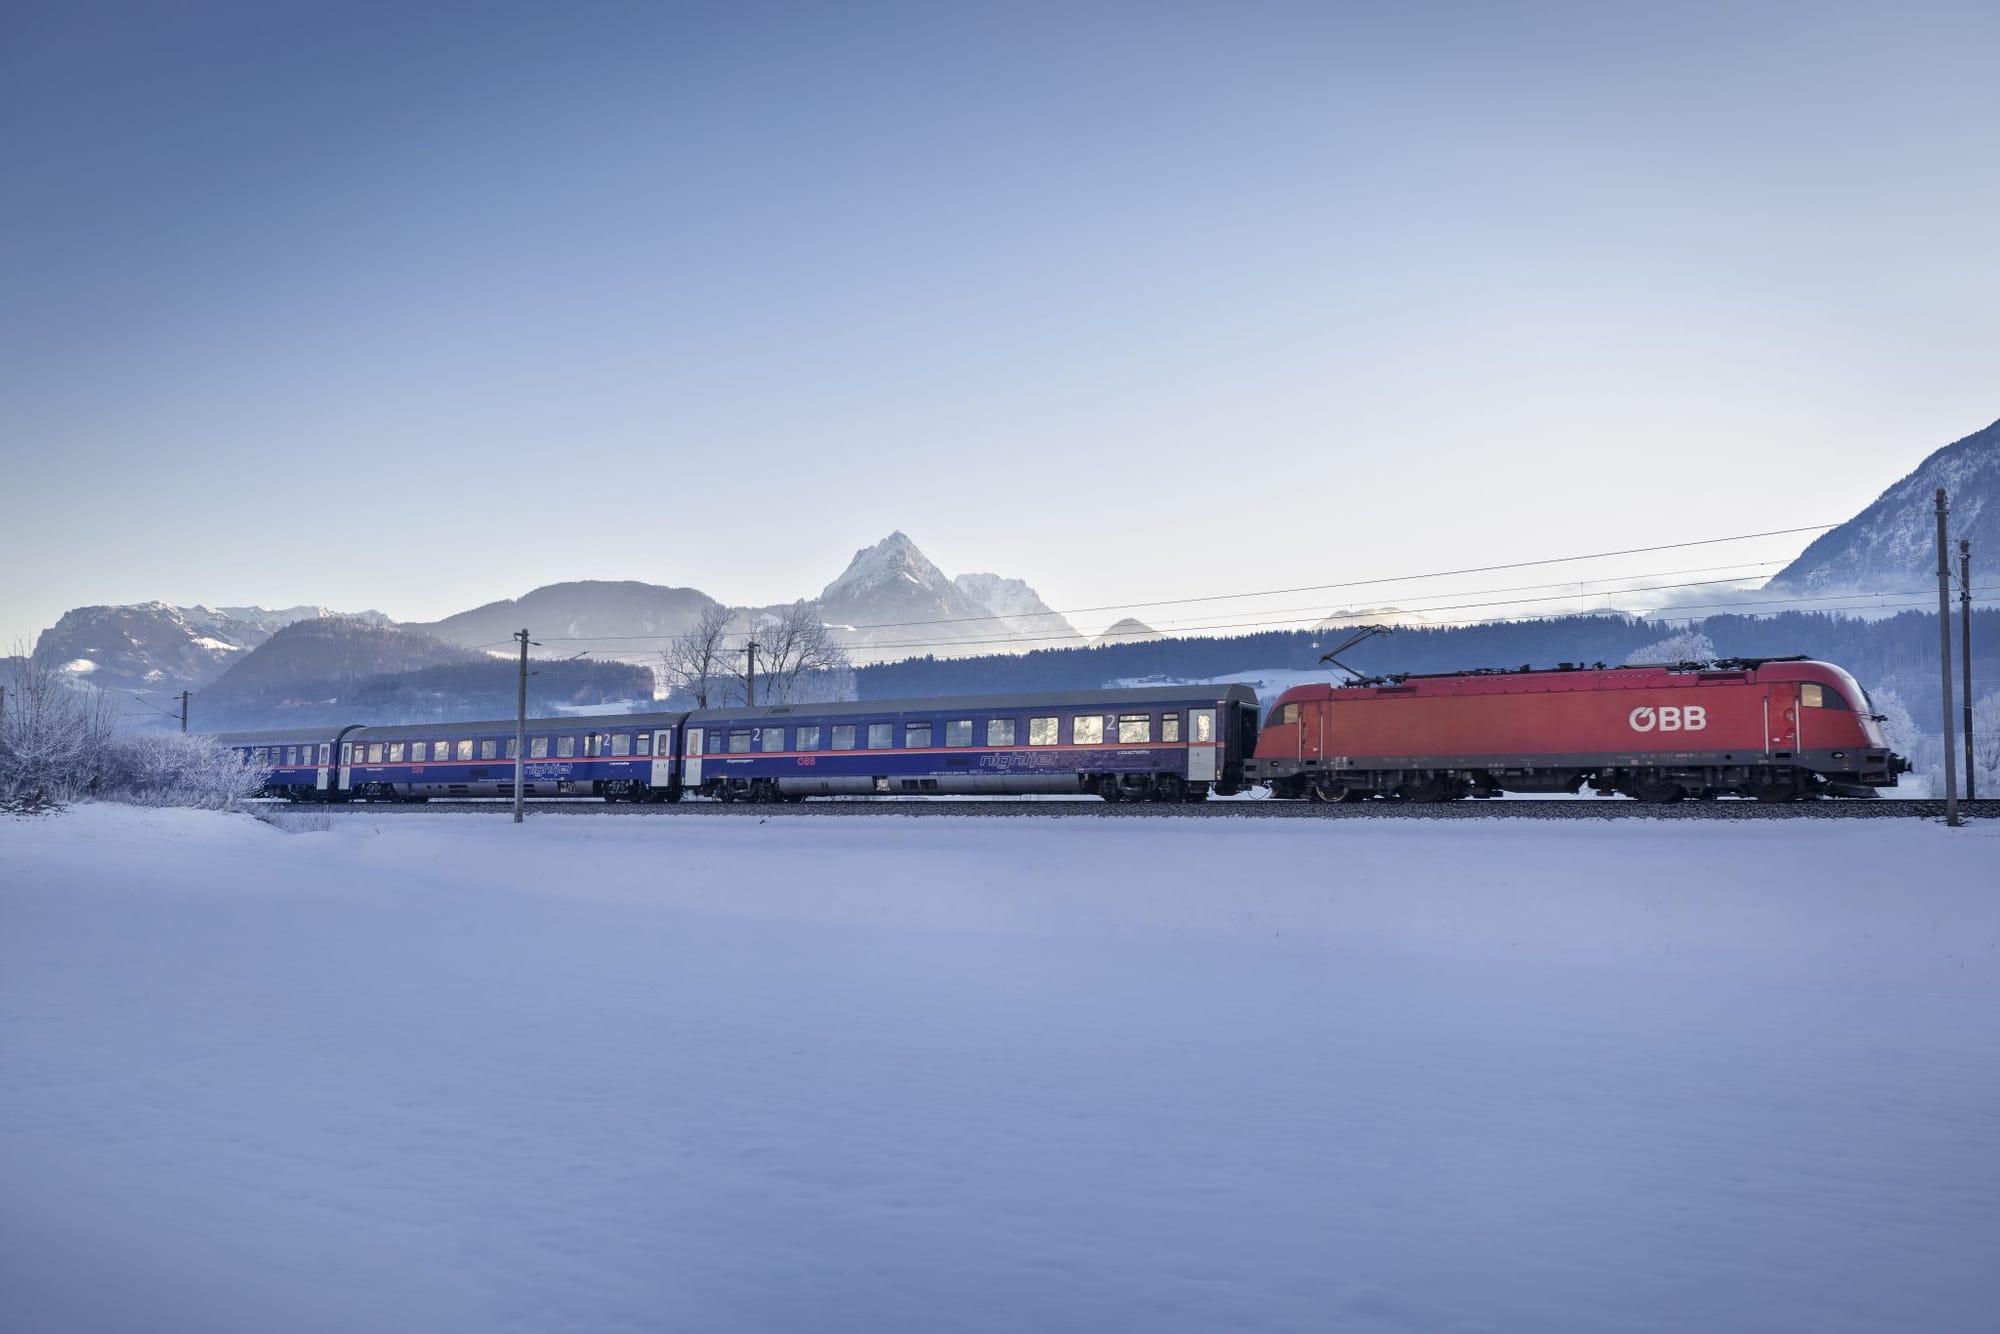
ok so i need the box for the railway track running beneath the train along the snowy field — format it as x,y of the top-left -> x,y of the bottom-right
260,798 -> 2000,820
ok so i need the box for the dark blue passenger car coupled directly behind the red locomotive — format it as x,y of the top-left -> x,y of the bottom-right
682,686 -> 1256,802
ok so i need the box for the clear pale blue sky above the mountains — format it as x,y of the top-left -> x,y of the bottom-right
0,0 -> 2000,640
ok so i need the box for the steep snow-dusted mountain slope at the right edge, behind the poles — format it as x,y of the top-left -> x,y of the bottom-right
1766,422 -> 2000,596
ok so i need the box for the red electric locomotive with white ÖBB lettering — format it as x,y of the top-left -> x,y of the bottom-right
1244,658 -> 1910,802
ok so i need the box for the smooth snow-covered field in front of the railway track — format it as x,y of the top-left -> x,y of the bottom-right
0,806 -> 2000,1334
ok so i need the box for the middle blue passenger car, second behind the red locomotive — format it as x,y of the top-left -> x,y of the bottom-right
338,714 -> 684,802
